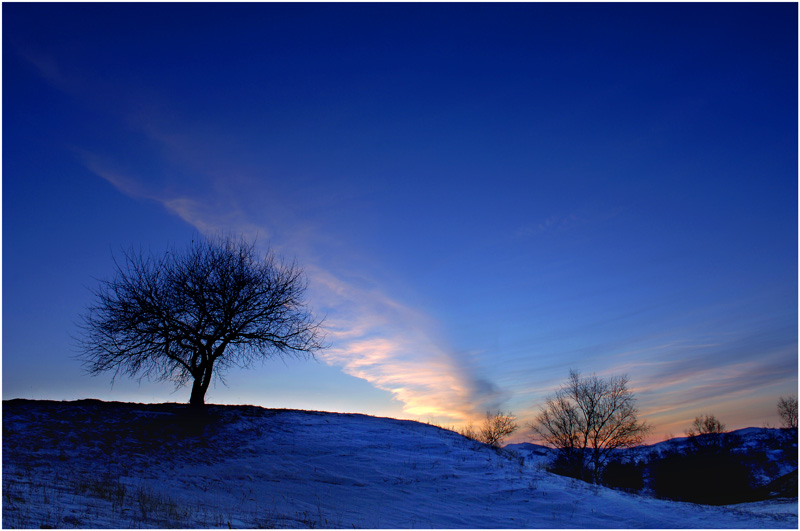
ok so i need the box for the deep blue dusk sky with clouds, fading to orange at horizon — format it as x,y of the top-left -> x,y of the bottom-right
2,3 -> 798,440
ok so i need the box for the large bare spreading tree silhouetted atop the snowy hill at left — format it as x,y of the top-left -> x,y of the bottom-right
79,237 -> 322,405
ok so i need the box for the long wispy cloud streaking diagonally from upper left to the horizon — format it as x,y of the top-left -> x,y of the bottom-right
36,44 -> 508,422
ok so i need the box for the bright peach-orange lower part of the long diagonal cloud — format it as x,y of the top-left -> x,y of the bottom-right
308,267 -> 506,422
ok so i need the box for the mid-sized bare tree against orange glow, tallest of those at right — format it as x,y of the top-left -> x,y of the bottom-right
531,370 -> 650,483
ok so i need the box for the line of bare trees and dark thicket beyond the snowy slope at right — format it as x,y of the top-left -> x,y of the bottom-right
531,371 -> 797,505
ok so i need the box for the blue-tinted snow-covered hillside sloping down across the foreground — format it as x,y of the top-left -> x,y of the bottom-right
2,400 -> 798,528
